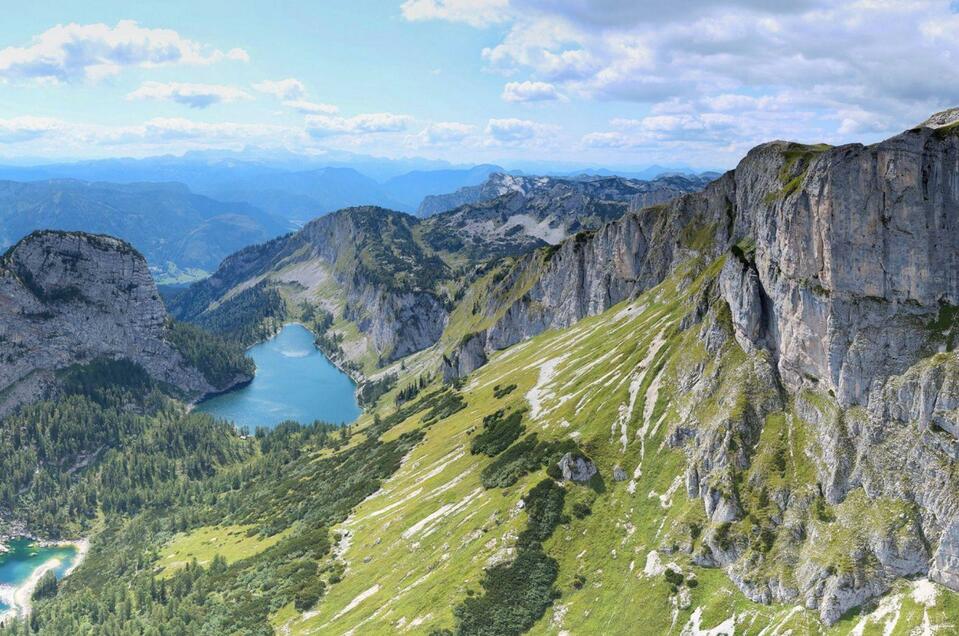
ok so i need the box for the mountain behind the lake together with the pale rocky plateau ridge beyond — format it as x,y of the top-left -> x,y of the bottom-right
171,173 -> 706,378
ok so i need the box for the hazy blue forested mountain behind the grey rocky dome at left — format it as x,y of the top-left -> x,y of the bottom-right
0,179 -> 289,280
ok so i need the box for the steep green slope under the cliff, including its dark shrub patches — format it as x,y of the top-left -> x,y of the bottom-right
290,257 -> 959,634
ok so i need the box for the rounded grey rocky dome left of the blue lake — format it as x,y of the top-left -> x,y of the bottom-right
0,232 -> 221,413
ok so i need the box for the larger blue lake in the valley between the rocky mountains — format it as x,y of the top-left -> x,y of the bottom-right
196,325 -> 360,432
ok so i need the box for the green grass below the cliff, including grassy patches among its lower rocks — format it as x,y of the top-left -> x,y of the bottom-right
260,251 -> 955,634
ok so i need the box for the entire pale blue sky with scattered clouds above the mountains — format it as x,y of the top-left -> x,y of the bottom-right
0,0 -> 959,169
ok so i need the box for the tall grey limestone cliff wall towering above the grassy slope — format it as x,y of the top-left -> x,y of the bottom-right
440,112 -> 959,623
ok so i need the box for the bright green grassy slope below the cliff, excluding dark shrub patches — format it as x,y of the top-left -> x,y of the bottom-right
244,255 -> 959,634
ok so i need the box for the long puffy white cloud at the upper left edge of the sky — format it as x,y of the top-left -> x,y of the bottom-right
0,20 -> 249,82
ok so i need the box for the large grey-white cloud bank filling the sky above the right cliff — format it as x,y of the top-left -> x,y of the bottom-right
458,0 -> 959,157
